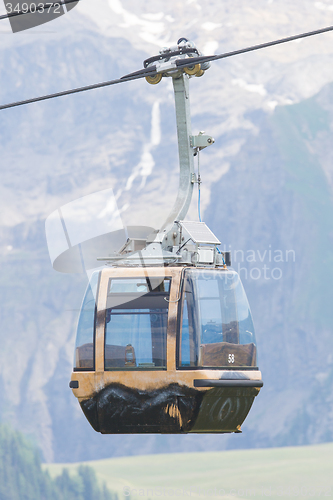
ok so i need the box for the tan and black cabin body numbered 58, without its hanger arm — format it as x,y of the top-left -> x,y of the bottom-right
71,266 -> 262,433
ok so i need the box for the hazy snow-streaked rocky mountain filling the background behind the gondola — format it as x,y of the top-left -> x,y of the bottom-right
0,0 -> 333,461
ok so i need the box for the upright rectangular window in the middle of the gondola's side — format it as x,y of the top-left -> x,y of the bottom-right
105,277 -> 171,370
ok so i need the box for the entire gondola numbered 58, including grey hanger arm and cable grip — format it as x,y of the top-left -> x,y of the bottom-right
70,38 -> 263,434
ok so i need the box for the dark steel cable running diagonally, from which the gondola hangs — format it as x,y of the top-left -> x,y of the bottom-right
0,23 -> 333,111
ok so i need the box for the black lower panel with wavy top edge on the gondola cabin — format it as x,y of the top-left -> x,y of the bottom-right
81,384 -> 258,434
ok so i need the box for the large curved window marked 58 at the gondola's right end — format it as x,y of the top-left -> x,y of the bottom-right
178,269 -> 256,368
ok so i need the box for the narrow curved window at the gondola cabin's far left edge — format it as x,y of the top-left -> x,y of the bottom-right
74,272 -> 100,370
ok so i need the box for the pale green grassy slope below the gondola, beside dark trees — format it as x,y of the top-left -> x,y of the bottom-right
44,443 -> 333,500
